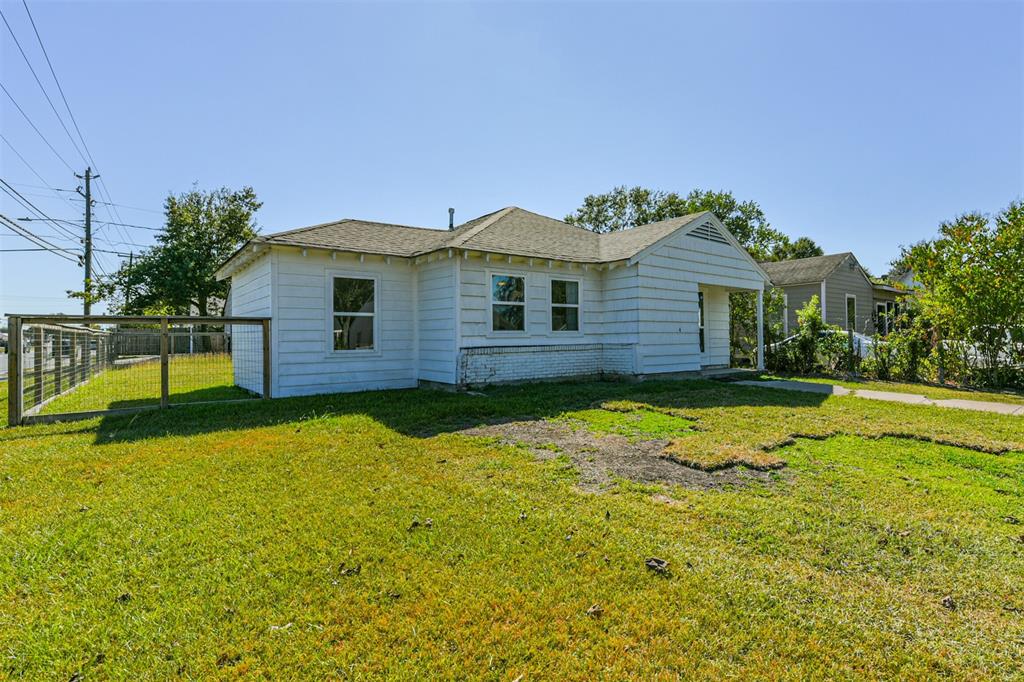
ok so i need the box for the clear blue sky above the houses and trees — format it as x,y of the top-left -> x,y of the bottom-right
0,0 -> 1024,312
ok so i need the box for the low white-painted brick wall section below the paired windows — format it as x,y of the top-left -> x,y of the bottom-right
459,343 -> 634,384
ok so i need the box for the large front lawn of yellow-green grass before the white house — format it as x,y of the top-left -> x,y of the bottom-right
0,374 -> 1024,680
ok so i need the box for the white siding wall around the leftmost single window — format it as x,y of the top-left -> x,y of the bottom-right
273,249 -> 417,397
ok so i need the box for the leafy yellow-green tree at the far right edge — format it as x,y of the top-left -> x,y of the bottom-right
902,202 -> 1024,385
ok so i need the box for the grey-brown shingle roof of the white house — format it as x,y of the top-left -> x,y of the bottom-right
247,206 -> 705,263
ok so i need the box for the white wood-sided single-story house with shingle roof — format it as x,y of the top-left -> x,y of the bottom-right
217,207 -> 768,396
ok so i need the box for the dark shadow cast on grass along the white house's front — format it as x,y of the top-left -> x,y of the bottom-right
86,380 -> 827,444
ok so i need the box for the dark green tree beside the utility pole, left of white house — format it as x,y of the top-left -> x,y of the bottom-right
101,187 -> 262,315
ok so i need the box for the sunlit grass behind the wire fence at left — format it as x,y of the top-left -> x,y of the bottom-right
26,353 -> 253,415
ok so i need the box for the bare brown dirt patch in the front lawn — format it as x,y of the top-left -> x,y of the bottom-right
460,420 -> 772,492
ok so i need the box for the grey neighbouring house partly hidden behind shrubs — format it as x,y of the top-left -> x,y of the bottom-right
761,252 -> 904,335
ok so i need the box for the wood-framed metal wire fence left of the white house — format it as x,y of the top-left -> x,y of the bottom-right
7,315 -> 270,425
